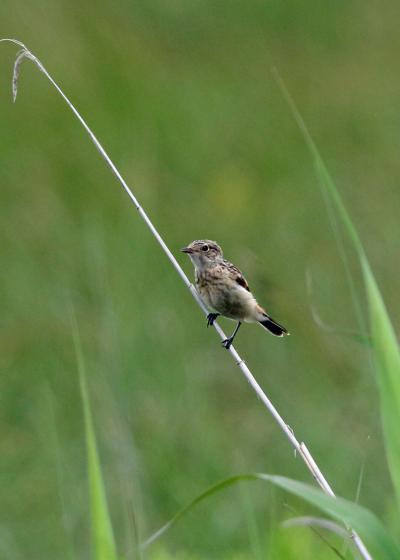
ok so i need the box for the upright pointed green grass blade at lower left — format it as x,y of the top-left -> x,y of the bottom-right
74,325 -> 117,560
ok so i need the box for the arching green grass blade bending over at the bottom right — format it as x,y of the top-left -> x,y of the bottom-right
142,473 -> 400,560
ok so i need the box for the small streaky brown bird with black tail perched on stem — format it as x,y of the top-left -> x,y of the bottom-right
181,239 -> 289,350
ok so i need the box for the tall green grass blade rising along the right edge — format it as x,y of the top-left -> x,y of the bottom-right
275,73 -> 400,507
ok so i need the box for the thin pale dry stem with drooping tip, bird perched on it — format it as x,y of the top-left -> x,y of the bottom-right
0,39 -> 372,560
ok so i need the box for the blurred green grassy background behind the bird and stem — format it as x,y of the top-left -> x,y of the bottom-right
0,0 -> 400,560
